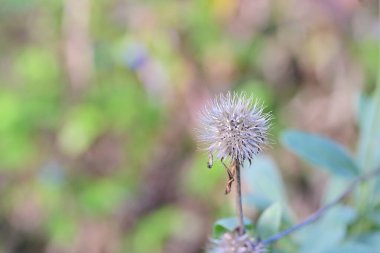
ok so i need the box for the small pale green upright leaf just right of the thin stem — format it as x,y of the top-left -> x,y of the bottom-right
257,203 -> 282,239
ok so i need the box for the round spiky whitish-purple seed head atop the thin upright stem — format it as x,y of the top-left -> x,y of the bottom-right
198,92 -> 271,164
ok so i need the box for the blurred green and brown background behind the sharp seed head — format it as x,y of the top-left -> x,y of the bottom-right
0,0 -> 379,253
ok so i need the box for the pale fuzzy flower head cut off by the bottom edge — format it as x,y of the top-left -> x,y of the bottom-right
209,232 -> 266,253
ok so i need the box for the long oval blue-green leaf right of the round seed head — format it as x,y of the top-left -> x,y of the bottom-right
281,130 -> 359,179
